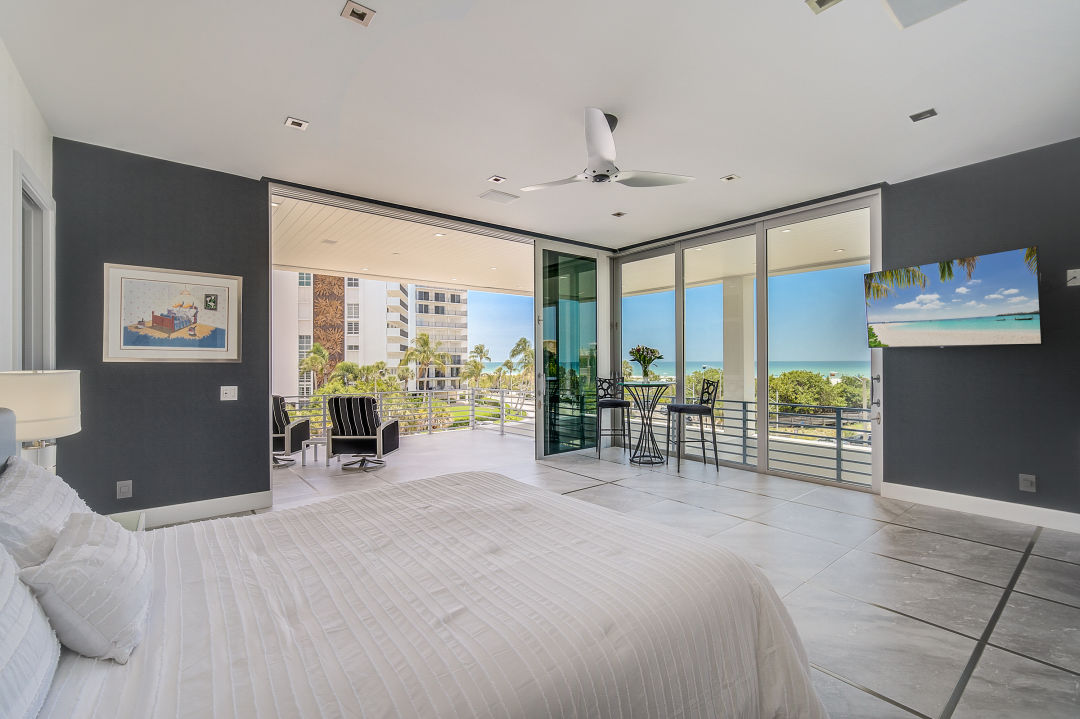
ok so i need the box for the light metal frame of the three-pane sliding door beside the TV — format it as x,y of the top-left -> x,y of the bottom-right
602,189 -> 885,493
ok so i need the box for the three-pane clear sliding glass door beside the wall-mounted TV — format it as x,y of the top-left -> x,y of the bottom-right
612,192 -> 882,489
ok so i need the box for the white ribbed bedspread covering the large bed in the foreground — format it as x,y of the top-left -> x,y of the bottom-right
41,473 -> 825,719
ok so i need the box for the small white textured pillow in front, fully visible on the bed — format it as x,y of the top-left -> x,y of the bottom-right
19,513 -> 153,664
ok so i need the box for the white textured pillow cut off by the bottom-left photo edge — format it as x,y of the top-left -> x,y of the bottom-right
0,547 -> 60,719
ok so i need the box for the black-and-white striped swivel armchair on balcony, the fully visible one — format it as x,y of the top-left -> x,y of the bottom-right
326,396 -> 399,471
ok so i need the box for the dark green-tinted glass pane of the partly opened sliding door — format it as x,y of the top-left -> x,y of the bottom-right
540,249 -> 597,455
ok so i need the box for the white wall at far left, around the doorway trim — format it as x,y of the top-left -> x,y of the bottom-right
0,35 -> 53,371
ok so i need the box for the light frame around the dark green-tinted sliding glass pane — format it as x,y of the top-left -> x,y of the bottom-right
532,240 -> 613,459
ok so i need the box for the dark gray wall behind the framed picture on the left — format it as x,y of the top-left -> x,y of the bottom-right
53,139 -> 270,513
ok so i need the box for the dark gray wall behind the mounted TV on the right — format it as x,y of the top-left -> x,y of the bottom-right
882,139 -> 1080,512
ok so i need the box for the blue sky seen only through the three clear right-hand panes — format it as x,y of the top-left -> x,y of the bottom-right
622,266 -> 869,363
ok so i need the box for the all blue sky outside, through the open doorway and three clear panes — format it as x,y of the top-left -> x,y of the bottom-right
469,263 -> 872,362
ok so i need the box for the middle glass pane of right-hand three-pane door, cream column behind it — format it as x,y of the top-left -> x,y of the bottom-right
683,234 -> 757,465
